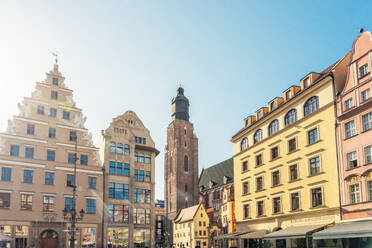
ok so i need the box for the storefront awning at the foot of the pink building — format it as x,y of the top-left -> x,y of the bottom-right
313,220 -> 372,239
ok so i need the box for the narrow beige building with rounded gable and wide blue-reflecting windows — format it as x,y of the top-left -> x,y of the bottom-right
99,111 -> 159,248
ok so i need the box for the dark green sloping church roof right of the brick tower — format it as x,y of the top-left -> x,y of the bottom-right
199,158 -> 234,191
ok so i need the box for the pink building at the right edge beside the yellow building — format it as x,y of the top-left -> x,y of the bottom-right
337,31 -> 372,220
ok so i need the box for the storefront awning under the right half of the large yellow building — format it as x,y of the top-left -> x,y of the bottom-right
264,224 -> 328,239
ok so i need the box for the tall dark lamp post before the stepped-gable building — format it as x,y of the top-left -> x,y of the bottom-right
62,135 -> 85,248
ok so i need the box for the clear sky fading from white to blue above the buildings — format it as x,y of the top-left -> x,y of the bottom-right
0,0 -> 372,199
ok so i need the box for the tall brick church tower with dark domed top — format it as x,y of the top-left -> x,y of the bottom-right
164,86 -> 199,224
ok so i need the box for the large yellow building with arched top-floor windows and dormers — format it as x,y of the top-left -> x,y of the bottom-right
232,51 -> 350,247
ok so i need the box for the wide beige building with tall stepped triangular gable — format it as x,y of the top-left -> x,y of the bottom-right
0,61 -> 102,248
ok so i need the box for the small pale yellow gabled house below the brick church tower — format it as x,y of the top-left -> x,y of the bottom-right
173,204 -> 209,248
